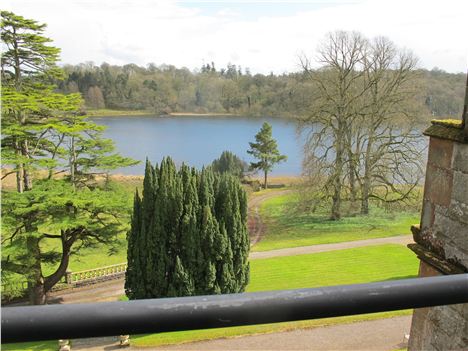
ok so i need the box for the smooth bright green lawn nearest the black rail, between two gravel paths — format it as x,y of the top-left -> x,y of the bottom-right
2,245 -> 419,351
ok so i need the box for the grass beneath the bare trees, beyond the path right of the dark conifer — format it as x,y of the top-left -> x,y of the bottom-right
252,193 -> 420,251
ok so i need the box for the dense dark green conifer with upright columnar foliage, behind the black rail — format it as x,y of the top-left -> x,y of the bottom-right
126,158 -> 249,299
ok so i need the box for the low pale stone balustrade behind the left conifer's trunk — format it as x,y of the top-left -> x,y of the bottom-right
1,262 -> 127,301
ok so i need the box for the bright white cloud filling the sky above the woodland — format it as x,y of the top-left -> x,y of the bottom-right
3,0 -> 468,73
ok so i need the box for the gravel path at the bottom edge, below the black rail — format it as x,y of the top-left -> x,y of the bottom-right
73,316 -> 411,351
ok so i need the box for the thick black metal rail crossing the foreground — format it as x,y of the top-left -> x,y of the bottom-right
2,274 -> 468,343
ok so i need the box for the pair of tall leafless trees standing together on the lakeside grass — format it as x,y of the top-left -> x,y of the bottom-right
301,32 -> 422,220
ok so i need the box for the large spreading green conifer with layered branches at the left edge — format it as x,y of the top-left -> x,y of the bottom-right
0,11 -> 136,304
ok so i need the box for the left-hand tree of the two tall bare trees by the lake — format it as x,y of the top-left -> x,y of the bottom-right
301,31 -> 368,220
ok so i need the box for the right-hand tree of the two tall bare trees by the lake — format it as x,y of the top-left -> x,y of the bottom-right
358,37 -> 422,214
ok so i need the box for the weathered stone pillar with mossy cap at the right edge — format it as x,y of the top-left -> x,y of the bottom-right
408,120 -> 468,351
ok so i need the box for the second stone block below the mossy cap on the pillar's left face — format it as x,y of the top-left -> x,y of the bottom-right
424,164 -> 453,207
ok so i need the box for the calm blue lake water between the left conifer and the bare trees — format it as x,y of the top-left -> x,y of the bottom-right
93,116 -> 302,175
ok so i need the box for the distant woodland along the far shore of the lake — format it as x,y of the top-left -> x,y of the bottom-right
58,63 -> 465,118
